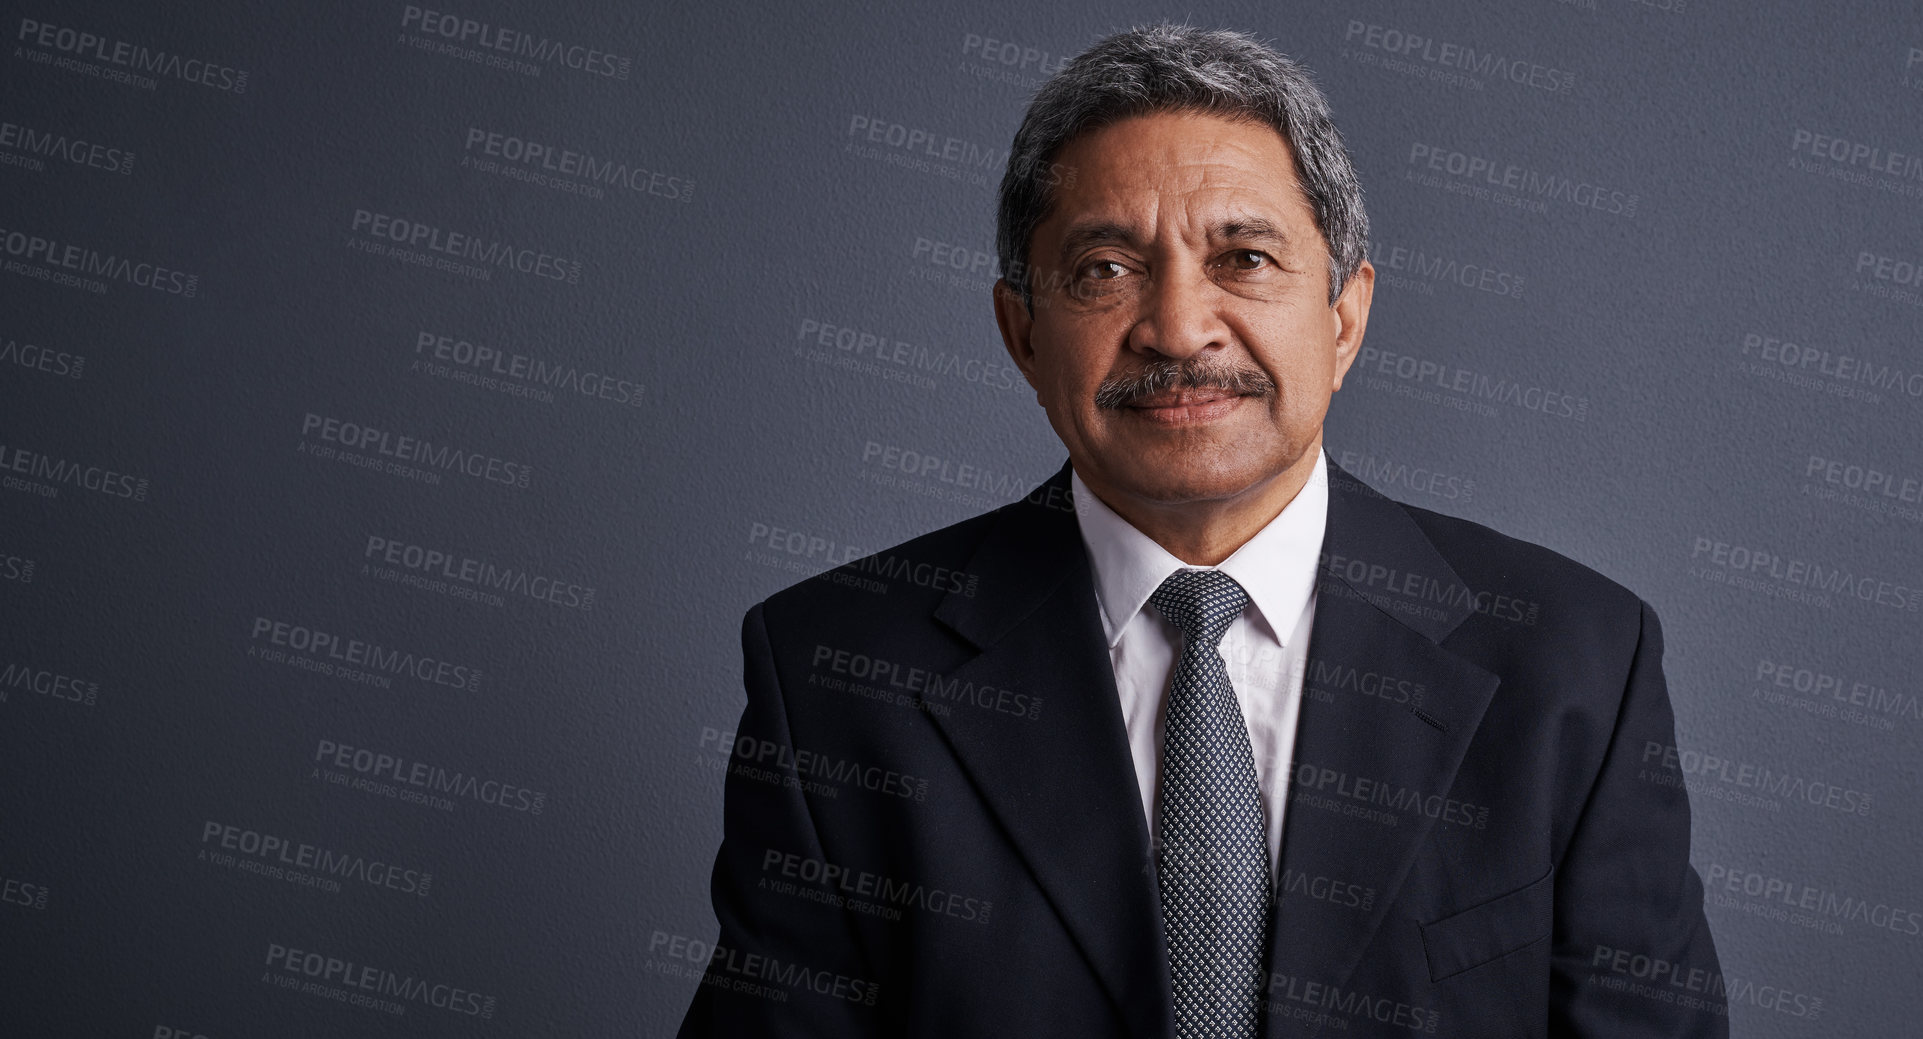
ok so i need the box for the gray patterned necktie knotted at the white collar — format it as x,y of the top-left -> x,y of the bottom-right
1148,570 -> 1269,1039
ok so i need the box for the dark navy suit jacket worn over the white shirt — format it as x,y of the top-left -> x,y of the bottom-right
681,462 -> 1727,1039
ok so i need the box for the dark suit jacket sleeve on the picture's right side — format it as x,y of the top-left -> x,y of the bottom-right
1550,602 -> 1729,1039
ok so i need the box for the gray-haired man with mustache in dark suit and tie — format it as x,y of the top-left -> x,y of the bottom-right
683,25 -> 1727,1039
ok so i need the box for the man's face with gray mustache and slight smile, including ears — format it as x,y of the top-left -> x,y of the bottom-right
996,112 -> 1375,506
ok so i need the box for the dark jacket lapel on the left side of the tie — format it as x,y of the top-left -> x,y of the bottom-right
929,464 -> 1173,1039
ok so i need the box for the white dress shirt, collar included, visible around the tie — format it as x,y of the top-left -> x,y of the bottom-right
1069,454 -> 1329,883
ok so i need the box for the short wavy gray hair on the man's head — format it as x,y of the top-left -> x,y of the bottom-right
994,23 -> 1369,312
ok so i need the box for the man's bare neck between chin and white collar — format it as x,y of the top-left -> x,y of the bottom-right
1083,433 -> 1321,566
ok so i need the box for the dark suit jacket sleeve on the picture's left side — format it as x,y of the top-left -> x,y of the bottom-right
679,604 -> 881,1039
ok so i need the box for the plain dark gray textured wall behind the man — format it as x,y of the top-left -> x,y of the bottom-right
0,0 -> 1923,1039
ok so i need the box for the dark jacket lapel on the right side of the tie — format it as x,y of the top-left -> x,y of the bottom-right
1267,462 -> 1498,1039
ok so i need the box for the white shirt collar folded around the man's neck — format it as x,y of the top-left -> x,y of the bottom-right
1069,452 -> 1329,646
